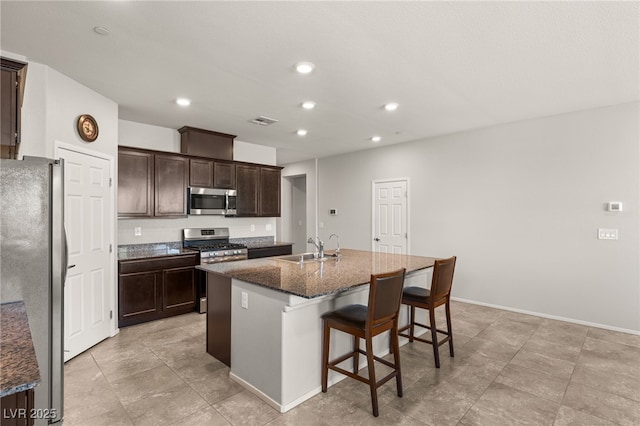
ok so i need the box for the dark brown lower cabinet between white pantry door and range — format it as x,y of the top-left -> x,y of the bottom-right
118,254 -> 197,327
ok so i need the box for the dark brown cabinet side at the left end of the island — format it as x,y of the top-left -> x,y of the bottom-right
207,272 -> 231,367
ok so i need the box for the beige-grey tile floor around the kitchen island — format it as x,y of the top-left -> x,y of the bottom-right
64,303 -> 640,426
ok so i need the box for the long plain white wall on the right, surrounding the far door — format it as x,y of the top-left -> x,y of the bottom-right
294,103 -> 640,332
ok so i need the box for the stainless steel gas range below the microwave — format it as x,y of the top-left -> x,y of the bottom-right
182,228 -> 247,265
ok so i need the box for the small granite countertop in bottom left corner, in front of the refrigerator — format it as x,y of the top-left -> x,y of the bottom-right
0,302 -> 40,397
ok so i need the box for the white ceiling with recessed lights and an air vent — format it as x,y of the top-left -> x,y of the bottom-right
0,0 -> 640,164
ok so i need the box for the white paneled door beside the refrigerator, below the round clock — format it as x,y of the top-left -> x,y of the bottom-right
58,148 -> 114,361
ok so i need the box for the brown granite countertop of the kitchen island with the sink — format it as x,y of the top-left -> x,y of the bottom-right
197,249 -> 436,299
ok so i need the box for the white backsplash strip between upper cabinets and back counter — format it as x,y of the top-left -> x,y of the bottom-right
118,216 -> 276,245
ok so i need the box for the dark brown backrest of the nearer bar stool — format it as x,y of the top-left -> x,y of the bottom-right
367,268 -> 405,327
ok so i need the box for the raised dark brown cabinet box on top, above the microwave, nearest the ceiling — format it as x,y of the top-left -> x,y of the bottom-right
178,126 -> 235,161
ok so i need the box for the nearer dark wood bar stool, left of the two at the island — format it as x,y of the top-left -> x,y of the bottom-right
322,268 -> 405,417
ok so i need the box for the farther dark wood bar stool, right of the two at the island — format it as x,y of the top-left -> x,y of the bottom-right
398,256 -> 456,368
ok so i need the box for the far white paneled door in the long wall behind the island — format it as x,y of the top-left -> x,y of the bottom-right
372,179 -> 409,254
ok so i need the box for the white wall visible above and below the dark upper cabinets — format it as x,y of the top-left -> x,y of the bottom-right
118,120 -> 277,245
